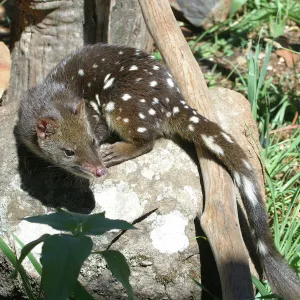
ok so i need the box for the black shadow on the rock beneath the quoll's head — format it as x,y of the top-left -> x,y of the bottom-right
14,126 -> 95,213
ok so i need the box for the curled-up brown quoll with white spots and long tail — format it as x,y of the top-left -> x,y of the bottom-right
16,44 -> 300,300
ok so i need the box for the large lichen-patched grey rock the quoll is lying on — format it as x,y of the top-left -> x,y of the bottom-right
0,89 -> 259,300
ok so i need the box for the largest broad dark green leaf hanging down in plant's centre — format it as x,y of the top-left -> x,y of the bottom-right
41,234 -> 93,300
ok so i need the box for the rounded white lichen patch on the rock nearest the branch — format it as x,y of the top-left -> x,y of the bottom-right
150,210 -> 189,254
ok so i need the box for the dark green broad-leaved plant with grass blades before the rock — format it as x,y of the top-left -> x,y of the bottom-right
0,210 -> 134,300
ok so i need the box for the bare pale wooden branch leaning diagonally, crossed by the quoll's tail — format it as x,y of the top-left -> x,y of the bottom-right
139,0 -> 254,300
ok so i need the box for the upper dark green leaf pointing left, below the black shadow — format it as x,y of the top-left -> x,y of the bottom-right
23,210 -> 78,232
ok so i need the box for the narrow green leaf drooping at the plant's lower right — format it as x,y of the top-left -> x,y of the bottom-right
95,250 -> 134,300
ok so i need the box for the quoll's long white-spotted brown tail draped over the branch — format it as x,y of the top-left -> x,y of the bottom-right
170,106 -> 300,300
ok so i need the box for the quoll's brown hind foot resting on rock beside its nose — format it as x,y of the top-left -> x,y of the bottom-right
100,141 -> 154,167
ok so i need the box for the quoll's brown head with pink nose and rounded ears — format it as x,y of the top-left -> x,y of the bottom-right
36,100 -> 106,178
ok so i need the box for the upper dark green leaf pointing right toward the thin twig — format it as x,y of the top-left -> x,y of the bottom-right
81,214 -> 135,235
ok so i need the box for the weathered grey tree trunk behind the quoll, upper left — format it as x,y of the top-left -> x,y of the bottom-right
7,0 -> 84,104
